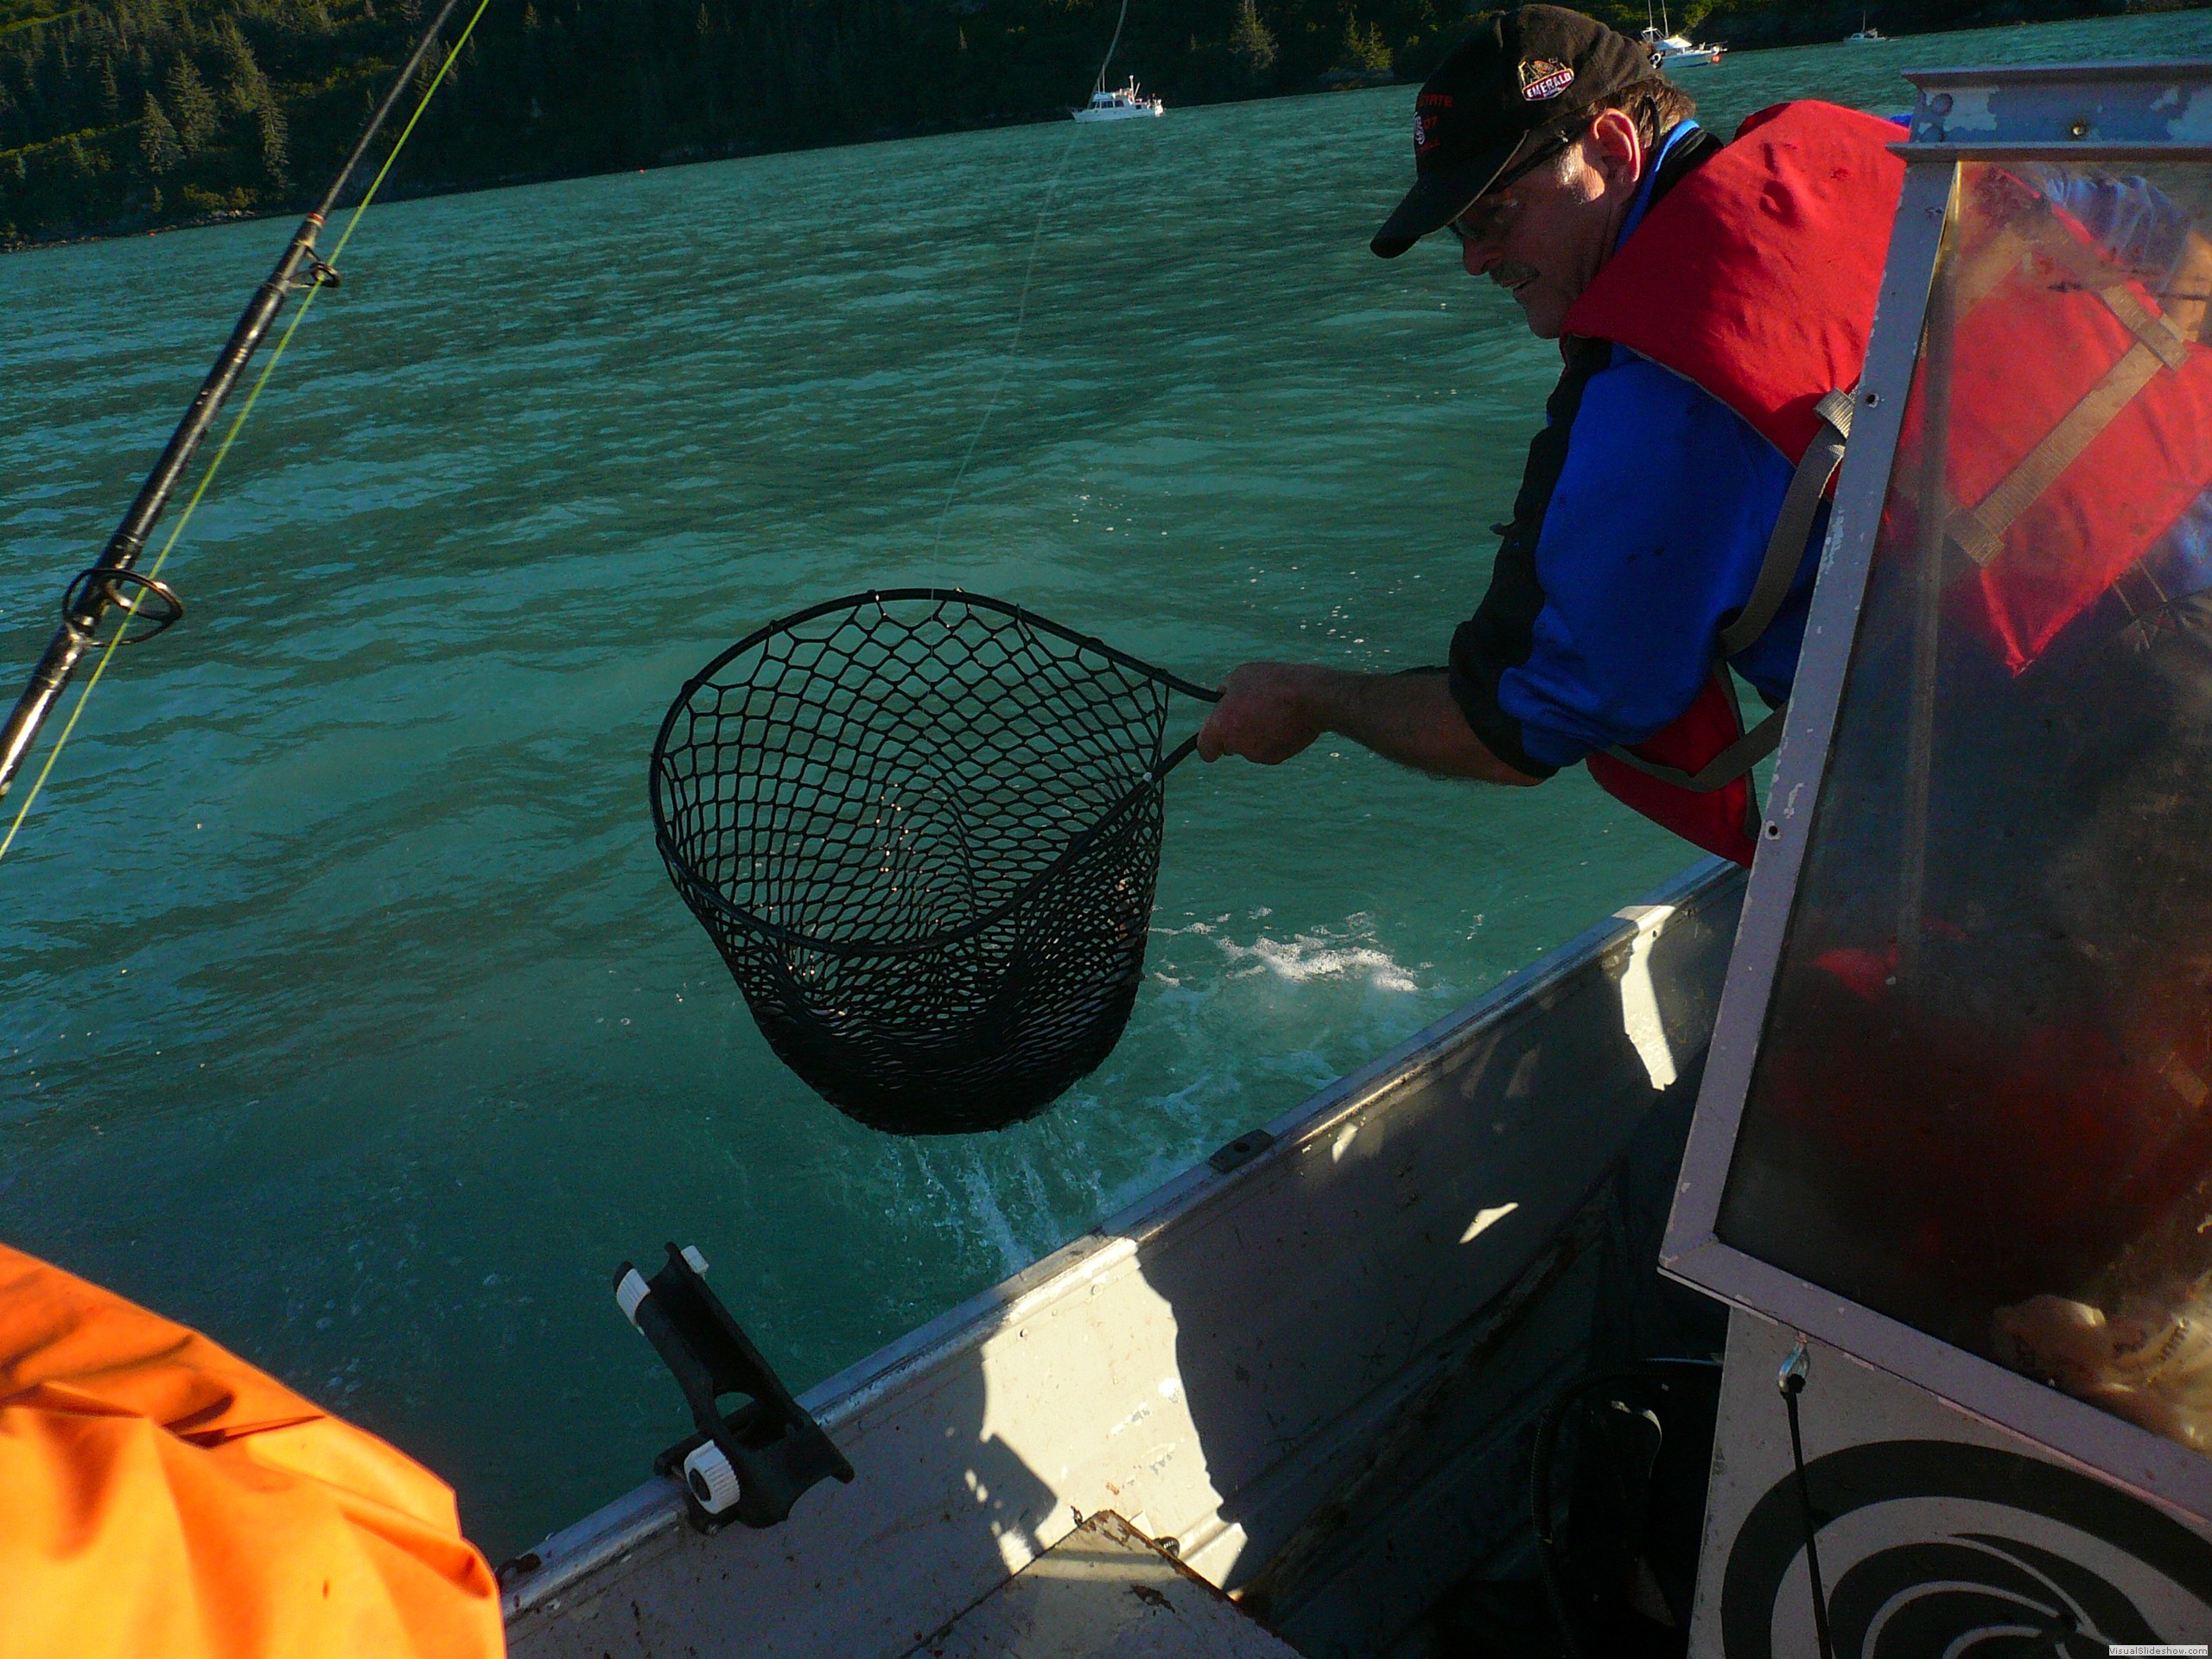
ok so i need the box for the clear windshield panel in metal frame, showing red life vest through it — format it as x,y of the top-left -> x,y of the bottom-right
1719,163 -> 2212,1451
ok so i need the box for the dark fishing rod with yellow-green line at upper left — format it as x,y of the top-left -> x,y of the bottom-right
0,0 -> 482,814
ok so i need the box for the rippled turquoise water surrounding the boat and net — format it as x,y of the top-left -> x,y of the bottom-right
0,13 -> 2212,1555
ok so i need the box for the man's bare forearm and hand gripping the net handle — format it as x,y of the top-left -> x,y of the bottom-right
1199,661 -> 1537,783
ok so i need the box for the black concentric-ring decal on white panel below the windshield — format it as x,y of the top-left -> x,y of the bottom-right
1721,1440 -> 2212,1659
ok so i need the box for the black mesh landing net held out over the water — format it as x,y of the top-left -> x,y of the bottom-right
652,588 -> 1217,1135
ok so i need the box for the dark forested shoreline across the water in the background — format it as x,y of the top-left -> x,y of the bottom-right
0,0 -> 2205,248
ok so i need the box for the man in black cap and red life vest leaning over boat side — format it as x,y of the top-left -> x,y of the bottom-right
1199,7 -> 1904,862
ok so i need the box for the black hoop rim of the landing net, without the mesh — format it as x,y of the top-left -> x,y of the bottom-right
646,588 -> 1221,957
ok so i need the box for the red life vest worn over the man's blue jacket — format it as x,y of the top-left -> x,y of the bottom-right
1566,102 -> 1904,865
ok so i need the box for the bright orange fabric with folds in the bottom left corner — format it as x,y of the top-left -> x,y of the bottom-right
0,1245 -> 506,1659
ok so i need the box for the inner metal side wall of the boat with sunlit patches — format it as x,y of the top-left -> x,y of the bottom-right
506,861 -> 1741,1659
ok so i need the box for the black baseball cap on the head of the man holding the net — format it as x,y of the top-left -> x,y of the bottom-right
1367,7 -> 1652,259
